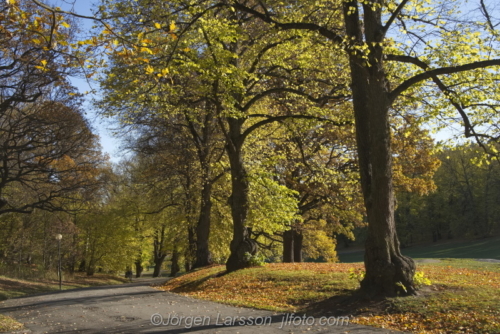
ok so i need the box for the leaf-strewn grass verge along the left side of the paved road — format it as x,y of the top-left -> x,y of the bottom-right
0,274 -> 128,332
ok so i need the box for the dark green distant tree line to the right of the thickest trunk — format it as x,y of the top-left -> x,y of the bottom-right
396,144 -> 500,246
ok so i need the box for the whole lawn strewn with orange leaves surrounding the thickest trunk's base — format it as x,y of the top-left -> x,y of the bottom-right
160,259 -> 500,333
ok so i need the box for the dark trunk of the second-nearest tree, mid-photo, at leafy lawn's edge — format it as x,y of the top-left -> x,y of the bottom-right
226,118 -> 257,272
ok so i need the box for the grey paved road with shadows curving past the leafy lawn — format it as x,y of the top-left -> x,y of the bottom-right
0,279 -> 404,334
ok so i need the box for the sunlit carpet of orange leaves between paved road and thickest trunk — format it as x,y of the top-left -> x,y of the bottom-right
161,263 -> 361,312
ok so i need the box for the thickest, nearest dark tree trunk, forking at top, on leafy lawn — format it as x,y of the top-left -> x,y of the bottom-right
344,1 -> 415,297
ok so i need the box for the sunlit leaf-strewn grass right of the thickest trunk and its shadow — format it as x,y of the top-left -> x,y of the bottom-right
356,259 -> 500,333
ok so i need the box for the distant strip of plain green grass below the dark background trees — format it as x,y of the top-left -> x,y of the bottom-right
338,237 -> 500,263
